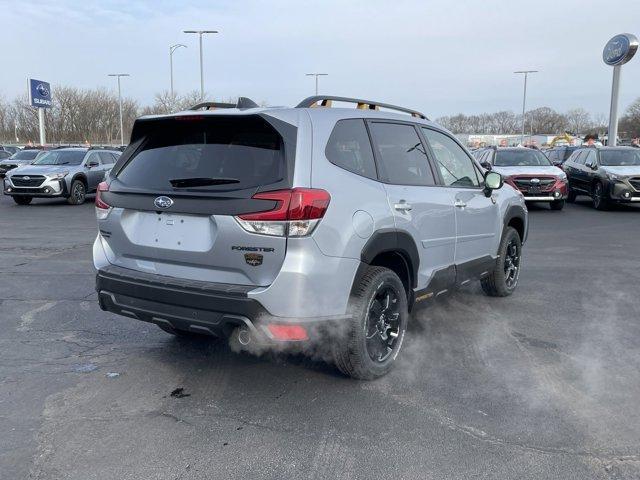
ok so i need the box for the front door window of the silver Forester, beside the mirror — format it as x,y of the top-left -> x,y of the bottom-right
422,128 -> 480,187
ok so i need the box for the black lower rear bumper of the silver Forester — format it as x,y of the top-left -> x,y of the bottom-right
96,265 -> 345,344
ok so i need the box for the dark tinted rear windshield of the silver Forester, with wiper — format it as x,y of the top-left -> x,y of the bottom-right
117,116 -> 285,191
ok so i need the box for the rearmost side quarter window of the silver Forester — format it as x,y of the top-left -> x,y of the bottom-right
325,119 -> 376,179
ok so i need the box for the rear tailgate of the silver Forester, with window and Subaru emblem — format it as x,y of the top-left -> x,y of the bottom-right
99,115 -> 295,286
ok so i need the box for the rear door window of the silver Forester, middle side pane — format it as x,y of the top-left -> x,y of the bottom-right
370,122 -> 435,185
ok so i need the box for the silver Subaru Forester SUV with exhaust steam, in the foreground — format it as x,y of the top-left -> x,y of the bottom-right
93,96 -> 528,379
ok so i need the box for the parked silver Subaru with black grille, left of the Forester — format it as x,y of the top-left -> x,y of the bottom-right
4,147 -> 121,205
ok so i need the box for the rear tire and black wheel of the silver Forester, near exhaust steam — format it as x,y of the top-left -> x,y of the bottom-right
333,267 -> 409,380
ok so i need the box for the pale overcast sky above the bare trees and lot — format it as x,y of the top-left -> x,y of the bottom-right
0,0 -> 640,117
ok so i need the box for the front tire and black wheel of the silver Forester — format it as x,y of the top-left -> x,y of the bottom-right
480,227 -> 522,297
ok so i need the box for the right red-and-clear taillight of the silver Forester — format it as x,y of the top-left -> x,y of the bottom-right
236,188 -> 331,237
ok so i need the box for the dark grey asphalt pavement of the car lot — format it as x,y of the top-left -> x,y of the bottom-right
0,193 -> 640,480
